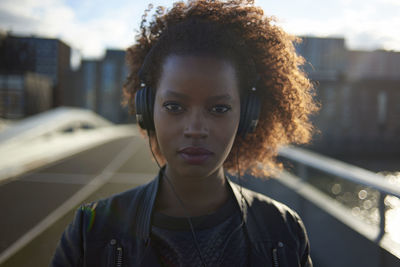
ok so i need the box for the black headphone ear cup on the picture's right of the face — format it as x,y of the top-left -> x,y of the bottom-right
238,92 -> 261,138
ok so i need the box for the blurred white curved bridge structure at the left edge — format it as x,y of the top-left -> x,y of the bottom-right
0,107 -> 137,183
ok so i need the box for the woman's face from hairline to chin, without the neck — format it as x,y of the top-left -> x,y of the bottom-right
154,55 -> 240,180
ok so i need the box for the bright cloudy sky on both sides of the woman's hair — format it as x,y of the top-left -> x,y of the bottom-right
0,0 -> 400,65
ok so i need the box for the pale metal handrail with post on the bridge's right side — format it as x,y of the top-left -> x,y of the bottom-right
279,146 -> 400,243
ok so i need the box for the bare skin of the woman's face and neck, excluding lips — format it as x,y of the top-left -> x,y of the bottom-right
154,55 -> 240,217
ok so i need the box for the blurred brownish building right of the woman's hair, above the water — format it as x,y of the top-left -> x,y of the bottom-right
296,37 -> 400,156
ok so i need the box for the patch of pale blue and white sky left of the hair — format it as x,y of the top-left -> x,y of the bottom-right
0,0 -> 178,57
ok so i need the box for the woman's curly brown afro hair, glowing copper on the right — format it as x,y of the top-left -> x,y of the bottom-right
123,0 -> 318,180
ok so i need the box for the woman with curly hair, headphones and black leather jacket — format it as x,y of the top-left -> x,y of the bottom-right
53,0 -> 317,266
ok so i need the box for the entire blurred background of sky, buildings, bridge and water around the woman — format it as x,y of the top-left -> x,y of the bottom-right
0,0 -> 400,266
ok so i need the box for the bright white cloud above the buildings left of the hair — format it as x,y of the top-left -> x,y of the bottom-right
0,0 -> 141,57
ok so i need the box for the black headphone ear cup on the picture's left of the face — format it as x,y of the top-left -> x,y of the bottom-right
135,87 -> 155,131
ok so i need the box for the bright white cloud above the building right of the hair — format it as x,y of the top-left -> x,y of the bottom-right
260,0 -> 400,51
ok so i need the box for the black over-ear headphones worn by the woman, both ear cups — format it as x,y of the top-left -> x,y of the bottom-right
135,67 -> 261,138
